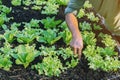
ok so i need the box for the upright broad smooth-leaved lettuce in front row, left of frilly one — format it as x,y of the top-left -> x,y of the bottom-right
12,44 -> 40,68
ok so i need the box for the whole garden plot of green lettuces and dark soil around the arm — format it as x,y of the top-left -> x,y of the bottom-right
0,0 -> 120,80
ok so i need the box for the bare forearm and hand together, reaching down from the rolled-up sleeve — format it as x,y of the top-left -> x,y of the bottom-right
65,13 -> 83,59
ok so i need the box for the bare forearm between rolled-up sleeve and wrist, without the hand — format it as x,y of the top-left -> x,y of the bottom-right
65,13 -> 81,37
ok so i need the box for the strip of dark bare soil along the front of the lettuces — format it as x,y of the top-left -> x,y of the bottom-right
0,58 -> 120,80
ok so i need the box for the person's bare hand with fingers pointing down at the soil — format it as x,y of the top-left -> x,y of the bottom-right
70,36 -> 83,59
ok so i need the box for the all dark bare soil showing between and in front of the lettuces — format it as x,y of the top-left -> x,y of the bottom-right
0,0 -> 120,80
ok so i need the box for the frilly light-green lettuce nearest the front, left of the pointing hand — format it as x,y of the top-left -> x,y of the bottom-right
34,56 -> 63,76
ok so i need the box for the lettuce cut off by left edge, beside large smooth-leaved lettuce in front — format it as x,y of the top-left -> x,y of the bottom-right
0,42 -> 14,71
